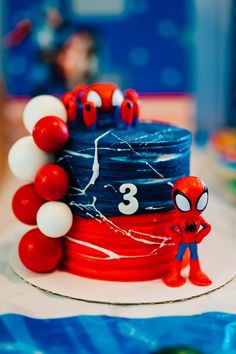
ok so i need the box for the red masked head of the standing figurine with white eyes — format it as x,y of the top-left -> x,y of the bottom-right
172,176 -> 208,219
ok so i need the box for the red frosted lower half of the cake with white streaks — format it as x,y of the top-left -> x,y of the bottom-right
62,211 -> 179,282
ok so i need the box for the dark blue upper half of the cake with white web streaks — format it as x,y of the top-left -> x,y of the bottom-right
56,123 -> 191,218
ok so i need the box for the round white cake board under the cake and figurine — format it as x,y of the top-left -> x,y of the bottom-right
10,224 -> 236,305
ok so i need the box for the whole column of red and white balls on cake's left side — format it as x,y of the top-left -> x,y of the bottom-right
8,95 -> 73,272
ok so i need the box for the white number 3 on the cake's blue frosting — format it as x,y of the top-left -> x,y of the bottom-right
118,183 -> 139,215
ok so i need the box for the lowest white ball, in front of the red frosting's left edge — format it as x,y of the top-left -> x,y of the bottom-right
37,202 -> 73,237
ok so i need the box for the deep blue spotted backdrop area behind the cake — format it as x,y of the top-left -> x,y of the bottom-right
5,0 -> 193,95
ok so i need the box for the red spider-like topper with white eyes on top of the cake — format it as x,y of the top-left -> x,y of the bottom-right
62,83 -> 139,128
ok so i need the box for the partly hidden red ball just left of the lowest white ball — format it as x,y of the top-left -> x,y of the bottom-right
12,183 -> 45,225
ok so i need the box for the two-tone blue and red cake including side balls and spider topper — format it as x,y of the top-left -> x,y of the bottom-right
9,84 -> 191,282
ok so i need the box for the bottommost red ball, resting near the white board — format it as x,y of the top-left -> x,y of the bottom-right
18,228 -> 62,273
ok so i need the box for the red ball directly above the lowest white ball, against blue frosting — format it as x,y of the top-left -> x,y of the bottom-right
34,164 -> 69,201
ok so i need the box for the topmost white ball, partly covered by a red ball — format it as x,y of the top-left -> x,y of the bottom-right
23,95 -> 67,133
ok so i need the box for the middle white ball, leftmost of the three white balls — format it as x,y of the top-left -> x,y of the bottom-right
8,136 -> 53,182
